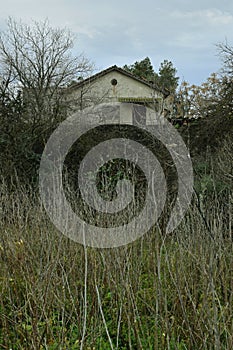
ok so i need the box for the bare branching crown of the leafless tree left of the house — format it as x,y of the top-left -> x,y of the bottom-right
0,18 -> 92,123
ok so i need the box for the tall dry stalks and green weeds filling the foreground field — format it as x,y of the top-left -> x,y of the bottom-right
0,133 -> 233,350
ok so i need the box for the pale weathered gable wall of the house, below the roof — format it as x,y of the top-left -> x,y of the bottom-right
65,71 -> 169,125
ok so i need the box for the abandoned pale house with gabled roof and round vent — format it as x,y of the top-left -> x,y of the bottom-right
67,66 -> 170,126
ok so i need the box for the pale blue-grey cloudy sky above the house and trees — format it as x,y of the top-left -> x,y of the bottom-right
0,0 -> 233,84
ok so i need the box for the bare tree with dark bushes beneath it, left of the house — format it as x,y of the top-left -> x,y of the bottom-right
0,18 -> 92,183
